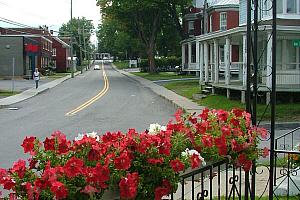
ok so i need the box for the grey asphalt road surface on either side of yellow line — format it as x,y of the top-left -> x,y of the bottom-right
0,61 -> 175,168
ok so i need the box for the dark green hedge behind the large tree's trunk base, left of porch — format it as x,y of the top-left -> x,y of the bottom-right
140,56 -> 181,72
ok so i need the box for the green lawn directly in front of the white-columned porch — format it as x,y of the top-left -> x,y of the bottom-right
164,80 -> 300,121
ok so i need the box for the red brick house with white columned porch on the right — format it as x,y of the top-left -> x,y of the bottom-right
182,0 -> 300,102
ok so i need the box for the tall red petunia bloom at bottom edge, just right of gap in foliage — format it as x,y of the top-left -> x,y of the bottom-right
119,172 -> 139,199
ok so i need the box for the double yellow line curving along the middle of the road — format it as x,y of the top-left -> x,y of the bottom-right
65,64 -> 109,116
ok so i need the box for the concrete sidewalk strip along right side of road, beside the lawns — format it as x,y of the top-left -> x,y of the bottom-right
112,65 -> 205,113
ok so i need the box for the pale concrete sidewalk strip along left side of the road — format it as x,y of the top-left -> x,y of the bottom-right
0,72 -> 80,109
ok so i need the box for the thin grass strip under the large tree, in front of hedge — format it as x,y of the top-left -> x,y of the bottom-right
133,72 -> 195,81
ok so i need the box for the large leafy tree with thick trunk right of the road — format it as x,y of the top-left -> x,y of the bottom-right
98,0 -> 191,73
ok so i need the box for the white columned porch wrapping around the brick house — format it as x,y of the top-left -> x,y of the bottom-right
182,26 -> 300,103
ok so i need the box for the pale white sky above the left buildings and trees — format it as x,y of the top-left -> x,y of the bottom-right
0,0 -> 100,43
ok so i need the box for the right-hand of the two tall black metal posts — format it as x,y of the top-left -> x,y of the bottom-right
269,0 -> 277,200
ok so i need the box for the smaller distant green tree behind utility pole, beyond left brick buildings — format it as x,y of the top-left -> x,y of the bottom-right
58,17 -> 94,65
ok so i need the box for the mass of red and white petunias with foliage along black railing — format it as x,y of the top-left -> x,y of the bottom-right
0,109 -> 268,199
